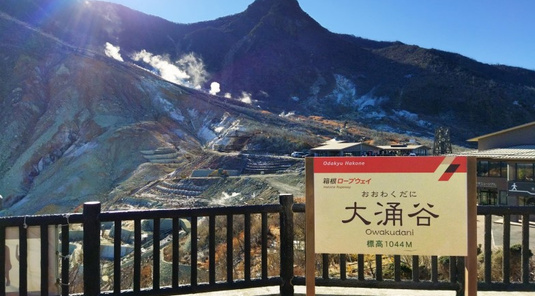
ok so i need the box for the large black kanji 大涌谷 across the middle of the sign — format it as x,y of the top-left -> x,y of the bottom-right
342,201 -> 440,226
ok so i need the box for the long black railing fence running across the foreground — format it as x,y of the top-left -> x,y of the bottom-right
0,195 -> 535,295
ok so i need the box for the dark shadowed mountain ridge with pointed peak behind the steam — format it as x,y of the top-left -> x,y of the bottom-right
0,0 -> 535,142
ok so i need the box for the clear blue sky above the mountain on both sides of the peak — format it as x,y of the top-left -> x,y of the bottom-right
96,0 -> 535,70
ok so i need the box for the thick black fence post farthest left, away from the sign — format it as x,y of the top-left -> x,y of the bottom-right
83,202 -> 100,296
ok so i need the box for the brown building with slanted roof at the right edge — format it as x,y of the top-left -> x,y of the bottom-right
461,121 -> 535,206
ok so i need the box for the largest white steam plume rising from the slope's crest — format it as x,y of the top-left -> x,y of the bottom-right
132,49 -> 208,89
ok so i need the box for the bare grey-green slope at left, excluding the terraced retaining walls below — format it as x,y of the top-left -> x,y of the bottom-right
0,7 -> 336,215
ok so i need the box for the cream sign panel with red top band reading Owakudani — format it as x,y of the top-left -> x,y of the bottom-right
313,156 -> 468,256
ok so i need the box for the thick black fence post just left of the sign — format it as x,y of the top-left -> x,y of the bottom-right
279,194 -> 294,296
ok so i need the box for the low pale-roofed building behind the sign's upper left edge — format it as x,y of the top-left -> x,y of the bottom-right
310,141 -> 380,156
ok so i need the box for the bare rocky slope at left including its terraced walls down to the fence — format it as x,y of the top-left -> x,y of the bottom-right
0,8 -> 348,215
